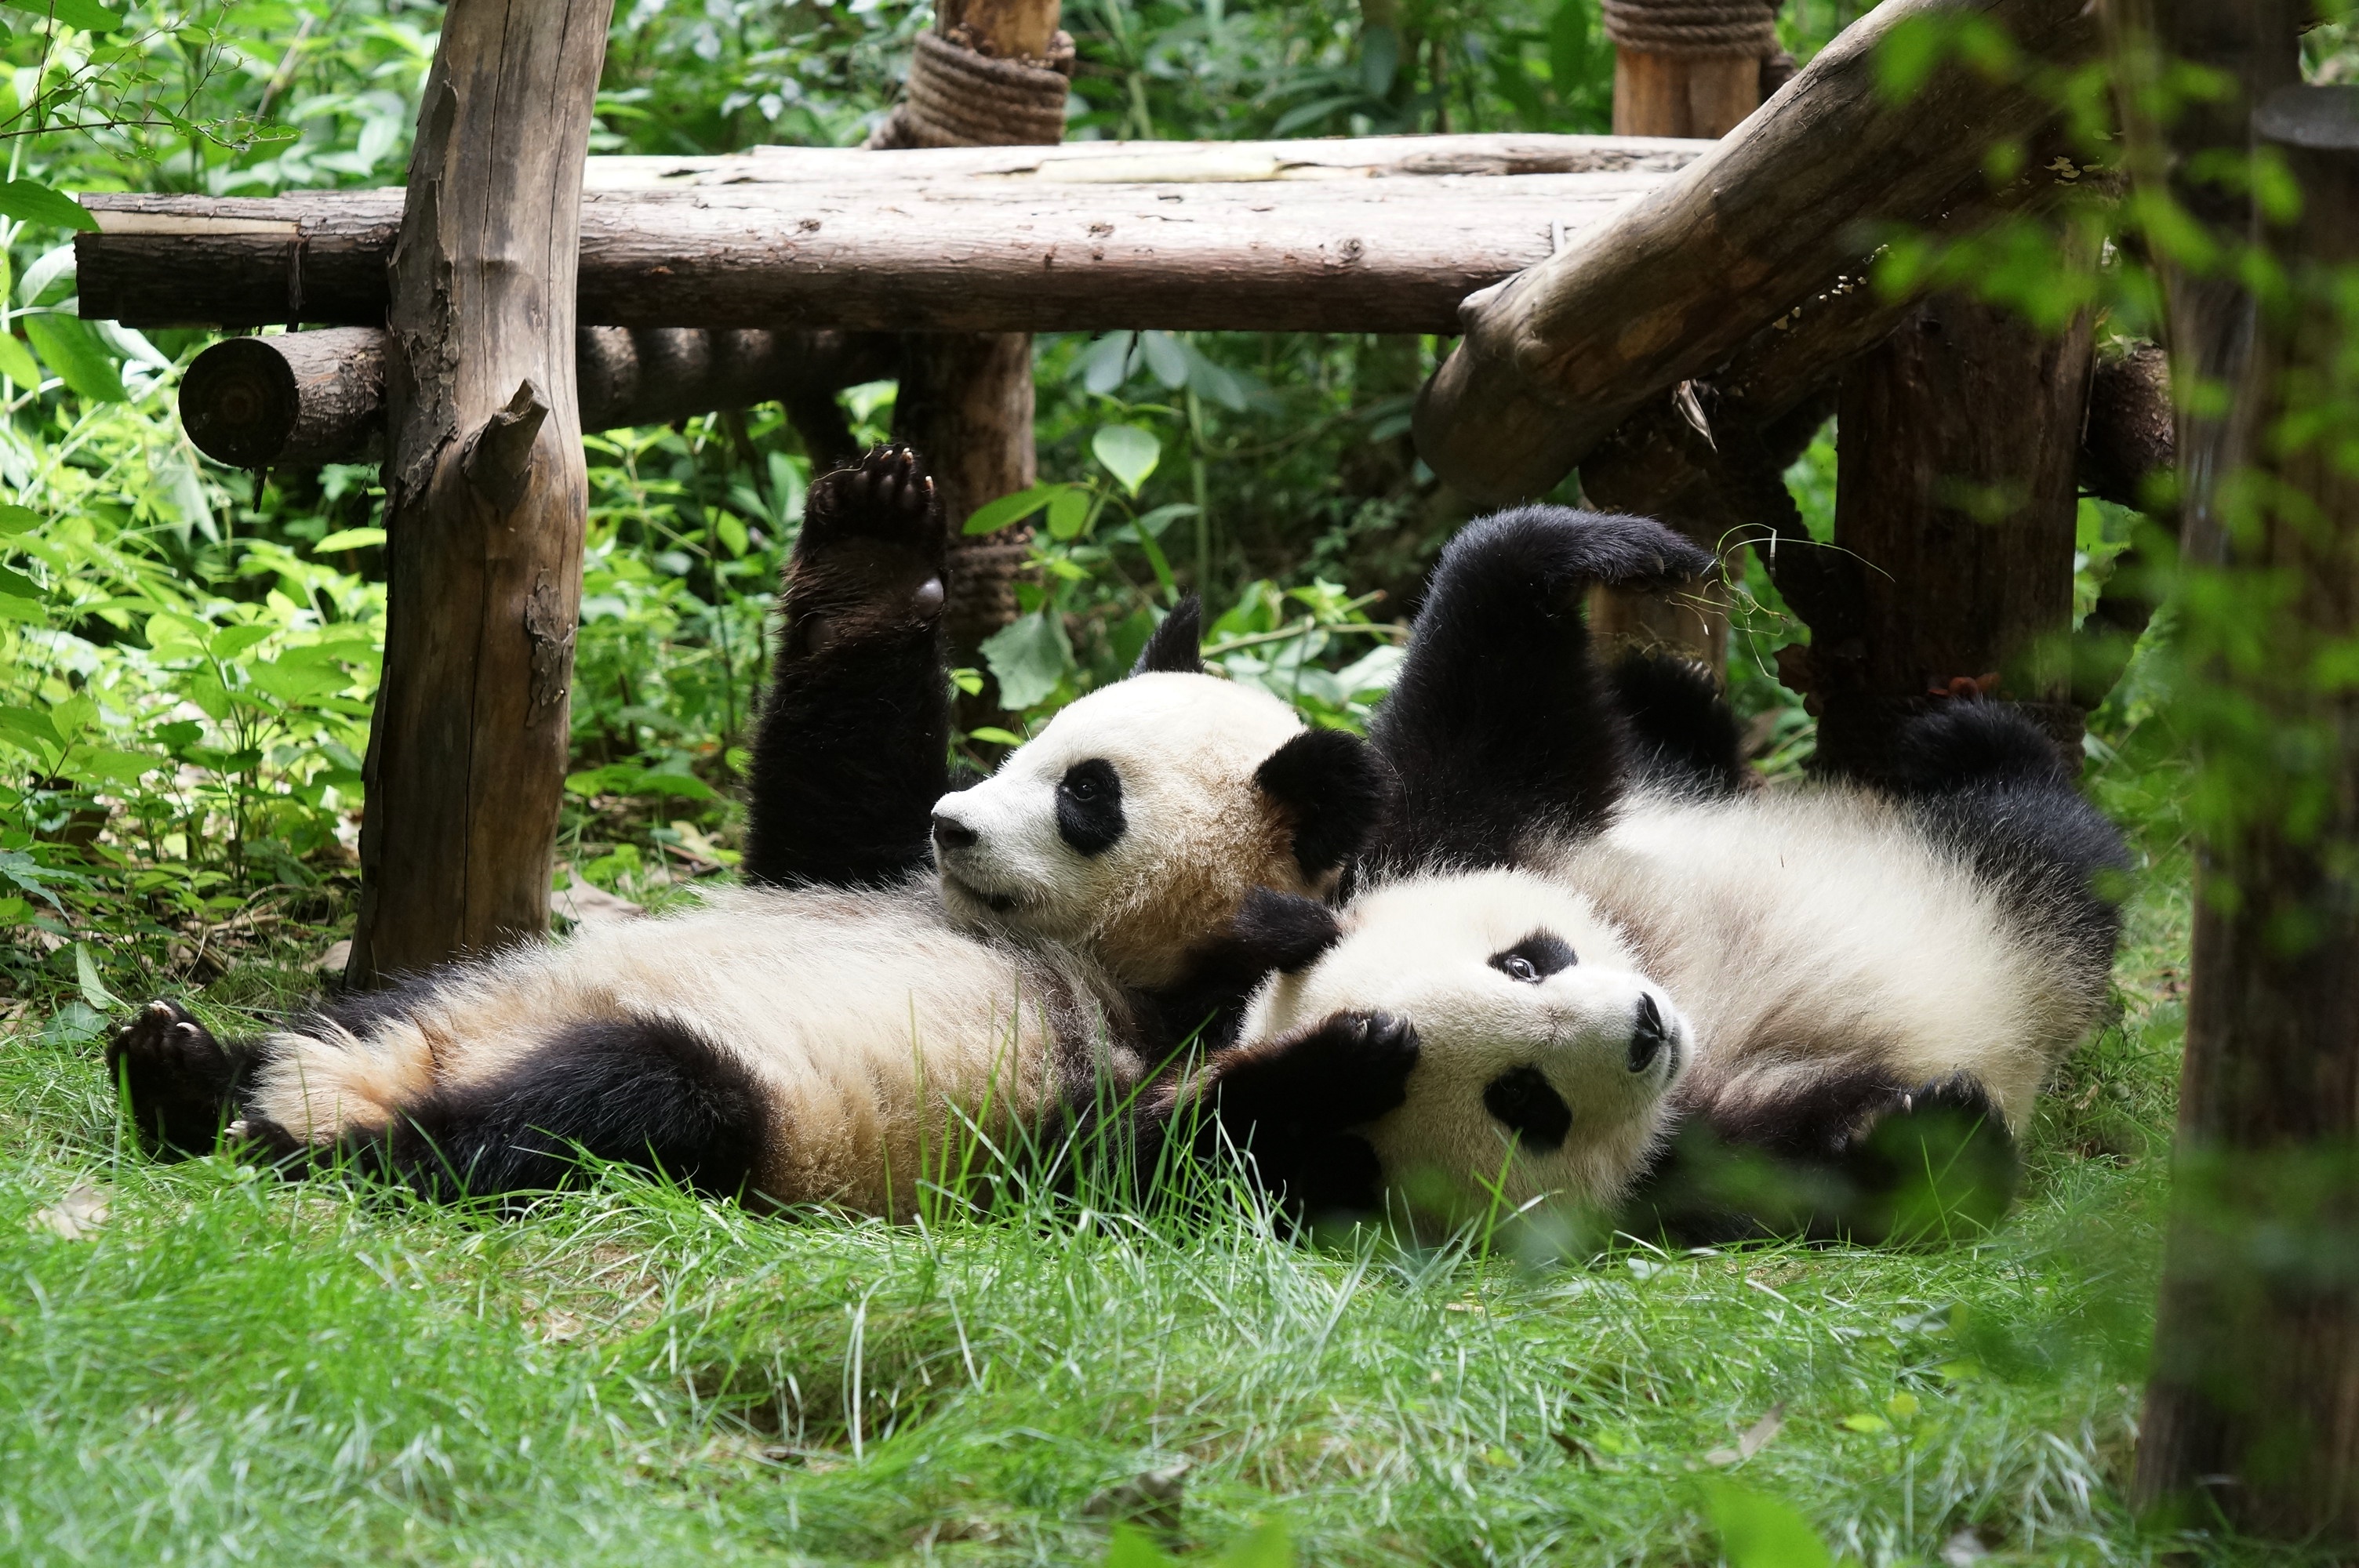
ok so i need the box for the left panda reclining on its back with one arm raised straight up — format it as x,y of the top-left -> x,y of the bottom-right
106,450 -> 1383,1217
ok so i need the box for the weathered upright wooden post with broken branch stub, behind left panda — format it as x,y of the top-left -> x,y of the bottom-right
347,0 -> 613,985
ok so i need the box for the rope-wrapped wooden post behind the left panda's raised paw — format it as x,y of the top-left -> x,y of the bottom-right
894,0 -> 1071,665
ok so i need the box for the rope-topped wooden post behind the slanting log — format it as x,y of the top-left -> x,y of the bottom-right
1590,0 -> 1776,665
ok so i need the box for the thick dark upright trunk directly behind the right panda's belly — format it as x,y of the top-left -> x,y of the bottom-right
1783,295 -> 2092,780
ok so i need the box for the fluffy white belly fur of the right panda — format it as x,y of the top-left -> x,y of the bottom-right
1557,788 -> 2104,1132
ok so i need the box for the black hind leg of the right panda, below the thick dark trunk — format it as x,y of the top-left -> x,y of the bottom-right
1894,698 -> 2130,971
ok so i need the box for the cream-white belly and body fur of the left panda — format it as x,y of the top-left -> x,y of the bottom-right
250,882 -> 1140,1217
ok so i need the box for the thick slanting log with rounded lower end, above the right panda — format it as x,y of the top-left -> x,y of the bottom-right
1416,0 -> 2097,503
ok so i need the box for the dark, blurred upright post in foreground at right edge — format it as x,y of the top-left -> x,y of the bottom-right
2132,82 -> 2359,1527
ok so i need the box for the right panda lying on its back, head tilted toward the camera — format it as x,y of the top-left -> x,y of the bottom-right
1156,510 -> 2125,1240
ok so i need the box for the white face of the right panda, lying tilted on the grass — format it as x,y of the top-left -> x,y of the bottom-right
1241,870 -> 1694,1224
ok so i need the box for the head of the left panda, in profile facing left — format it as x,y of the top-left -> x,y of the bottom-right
934,597 -> 1383,985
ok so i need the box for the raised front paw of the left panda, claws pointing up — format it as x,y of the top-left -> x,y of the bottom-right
786,445 -> 951,653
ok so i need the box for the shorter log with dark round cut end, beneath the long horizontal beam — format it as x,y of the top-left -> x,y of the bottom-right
180,328 -> 894,469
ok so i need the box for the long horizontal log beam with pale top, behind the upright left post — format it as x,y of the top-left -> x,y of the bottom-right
75,136 -> 1708,332
